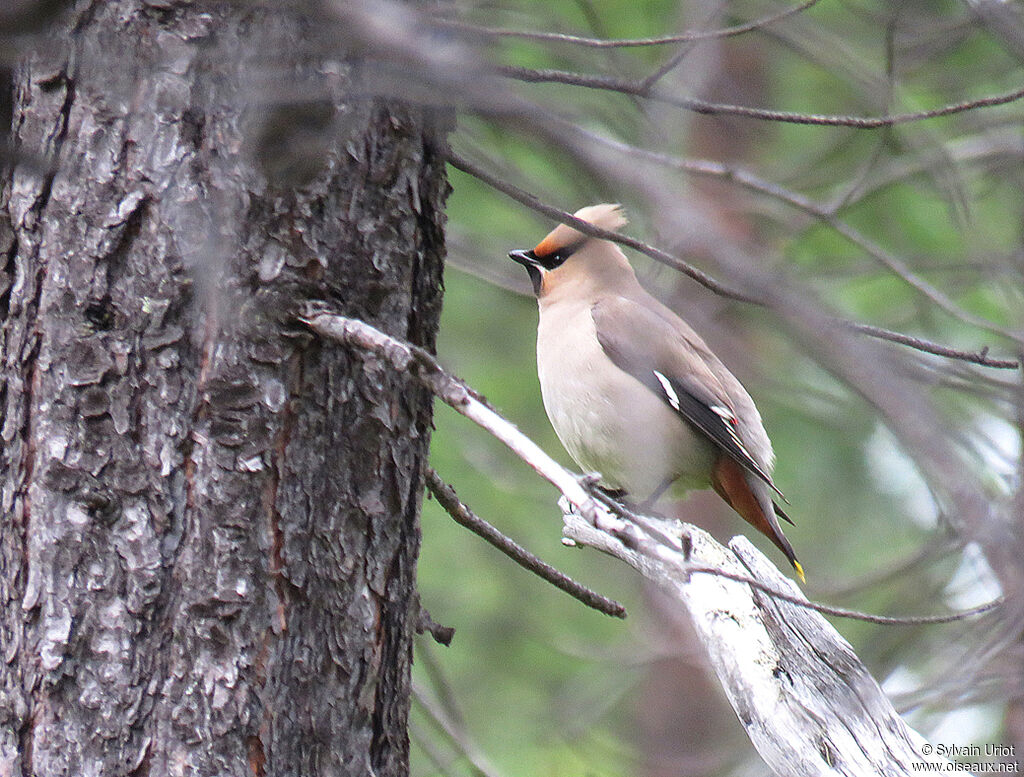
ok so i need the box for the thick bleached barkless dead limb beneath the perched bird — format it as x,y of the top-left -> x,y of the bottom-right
563,501 -> 954,777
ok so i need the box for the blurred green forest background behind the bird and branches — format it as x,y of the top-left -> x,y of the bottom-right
412,0 -> 1024,777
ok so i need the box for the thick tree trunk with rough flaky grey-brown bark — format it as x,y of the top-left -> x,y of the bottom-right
0,0 -> 446,777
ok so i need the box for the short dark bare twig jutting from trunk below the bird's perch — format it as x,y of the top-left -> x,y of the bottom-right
425,468 -> 626,618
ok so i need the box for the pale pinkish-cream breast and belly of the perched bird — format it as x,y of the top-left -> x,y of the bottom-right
537,304 -> 713,499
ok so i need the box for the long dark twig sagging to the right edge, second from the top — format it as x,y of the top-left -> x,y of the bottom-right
497,66 -> 1024,129
